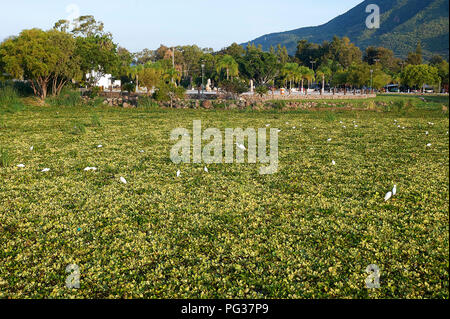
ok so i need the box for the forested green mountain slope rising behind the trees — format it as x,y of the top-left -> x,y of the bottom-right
243,0 -> 449,59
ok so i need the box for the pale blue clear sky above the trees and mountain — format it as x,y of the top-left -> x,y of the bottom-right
0,0 -> 362,52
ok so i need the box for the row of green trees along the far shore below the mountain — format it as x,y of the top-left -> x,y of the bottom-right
0,16 -> 449,100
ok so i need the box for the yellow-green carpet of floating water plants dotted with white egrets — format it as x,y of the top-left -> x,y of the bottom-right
0,97 -> 449,298
